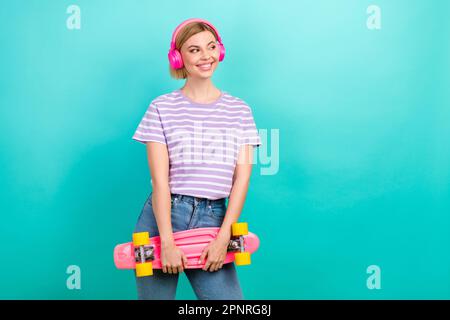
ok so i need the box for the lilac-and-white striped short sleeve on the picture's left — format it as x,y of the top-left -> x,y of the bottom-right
132,102 -> 167,144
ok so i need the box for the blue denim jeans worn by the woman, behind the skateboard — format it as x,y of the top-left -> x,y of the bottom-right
134,193 -> 243,300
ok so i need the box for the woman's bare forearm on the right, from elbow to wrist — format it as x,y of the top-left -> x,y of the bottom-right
219,178 -> 250,238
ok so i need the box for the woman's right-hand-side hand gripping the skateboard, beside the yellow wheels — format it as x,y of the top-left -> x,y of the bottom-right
198,233 -> 230,272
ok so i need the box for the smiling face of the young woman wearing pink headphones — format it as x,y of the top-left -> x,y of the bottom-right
181,31 -> 220,78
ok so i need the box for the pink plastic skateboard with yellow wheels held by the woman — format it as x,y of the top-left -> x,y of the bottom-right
114,223 -> 259,277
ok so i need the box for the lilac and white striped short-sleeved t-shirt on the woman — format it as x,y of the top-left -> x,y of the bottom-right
132,89 -> 261,200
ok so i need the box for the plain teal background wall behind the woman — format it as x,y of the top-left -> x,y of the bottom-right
0,0 -> 450,299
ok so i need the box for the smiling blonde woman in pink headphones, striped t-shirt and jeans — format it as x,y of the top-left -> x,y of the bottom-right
133,19 -> 261,299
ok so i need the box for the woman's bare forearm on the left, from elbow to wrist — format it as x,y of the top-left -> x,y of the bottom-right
150,181 -> 174,246
